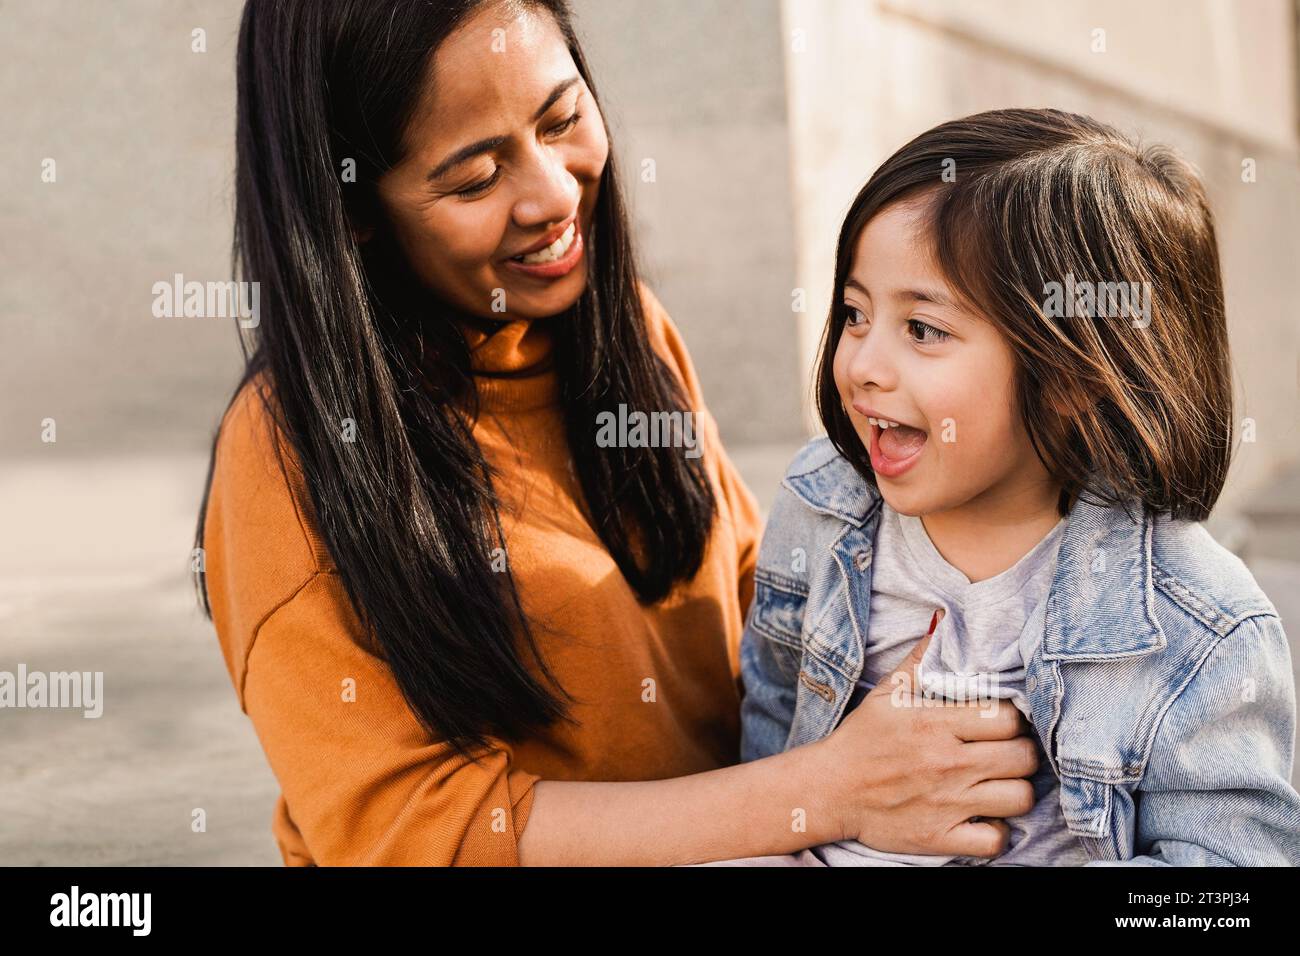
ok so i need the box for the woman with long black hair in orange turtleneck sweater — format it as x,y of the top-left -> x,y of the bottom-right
198,0 -> 1036,865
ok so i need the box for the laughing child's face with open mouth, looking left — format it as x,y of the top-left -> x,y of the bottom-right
833,203 -> 1049,515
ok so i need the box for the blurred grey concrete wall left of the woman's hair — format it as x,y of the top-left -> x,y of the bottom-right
0,0 -> 242,459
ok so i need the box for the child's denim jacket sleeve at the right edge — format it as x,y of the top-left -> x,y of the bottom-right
1088,614 -> 1300,866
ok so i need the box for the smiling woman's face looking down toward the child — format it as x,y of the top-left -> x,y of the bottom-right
378,4 -> 608,319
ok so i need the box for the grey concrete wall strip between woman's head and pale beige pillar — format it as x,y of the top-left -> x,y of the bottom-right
573,0 -> 802,445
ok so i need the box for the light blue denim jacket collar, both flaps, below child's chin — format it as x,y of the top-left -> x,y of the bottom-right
783,442 -> 1167,661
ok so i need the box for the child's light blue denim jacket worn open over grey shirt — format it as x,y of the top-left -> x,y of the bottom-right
741,436 -> 1300,865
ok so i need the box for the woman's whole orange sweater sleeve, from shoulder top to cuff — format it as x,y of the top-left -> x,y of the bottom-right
204,390 -> 540,866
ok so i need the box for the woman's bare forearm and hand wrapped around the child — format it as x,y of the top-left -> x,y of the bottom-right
519,640 -> 1037,866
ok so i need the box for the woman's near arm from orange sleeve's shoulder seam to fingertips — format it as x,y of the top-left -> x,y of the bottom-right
237,574 -> 1035,865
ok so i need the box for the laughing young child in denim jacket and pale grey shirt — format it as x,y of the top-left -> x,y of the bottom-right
740,109 -> 1300,865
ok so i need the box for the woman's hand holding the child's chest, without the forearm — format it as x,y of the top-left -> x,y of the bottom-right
813,613 -> 1039,857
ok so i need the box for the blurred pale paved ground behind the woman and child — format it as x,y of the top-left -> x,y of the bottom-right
0,446 -> 1300,865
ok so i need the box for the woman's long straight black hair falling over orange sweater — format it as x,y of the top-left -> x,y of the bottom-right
196,0 -> 716,756
